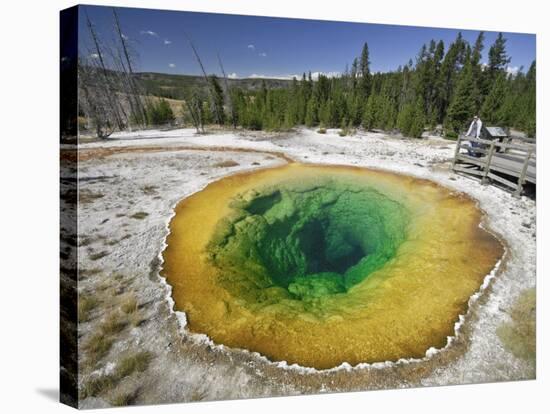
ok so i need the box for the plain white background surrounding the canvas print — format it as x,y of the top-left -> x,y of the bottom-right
0,0 -> 550,414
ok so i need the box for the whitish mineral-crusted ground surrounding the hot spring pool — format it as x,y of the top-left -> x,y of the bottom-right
69,129 -> 536,408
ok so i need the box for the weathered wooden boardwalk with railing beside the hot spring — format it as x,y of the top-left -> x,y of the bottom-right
452,137 -> 537,196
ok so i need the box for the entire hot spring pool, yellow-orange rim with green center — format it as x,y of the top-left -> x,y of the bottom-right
163,164 -> 503,369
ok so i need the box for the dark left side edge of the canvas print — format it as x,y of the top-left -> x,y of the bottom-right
59,6 -> 78,408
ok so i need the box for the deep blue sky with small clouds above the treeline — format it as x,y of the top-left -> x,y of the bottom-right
79,6 -> 536,77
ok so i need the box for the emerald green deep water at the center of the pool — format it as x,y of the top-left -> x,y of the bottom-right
207,179 -> 410,303
